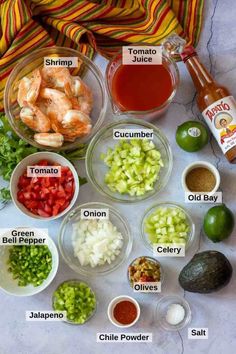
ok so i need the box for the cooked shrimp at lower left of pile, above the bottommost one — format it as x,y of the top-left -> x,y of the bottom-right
20,103 -> 51,133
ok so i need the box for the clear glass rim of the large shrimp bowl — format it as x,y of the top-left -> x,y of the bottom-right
3,46 -> 108,151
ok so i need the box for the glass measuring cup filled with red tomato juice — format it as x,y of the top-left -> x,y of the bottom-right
106,49 -> 179,119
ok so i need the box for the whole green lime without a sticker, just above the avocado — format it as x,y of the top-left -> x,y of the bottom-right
203,204 -> 234,242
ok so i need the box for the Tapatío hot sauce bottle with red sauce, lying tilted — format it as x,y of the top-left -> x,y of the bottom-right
180,46 -> 236,163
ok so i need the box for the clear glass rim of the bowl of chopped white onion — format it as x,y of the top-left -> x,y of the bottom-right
58,202 -> 133,276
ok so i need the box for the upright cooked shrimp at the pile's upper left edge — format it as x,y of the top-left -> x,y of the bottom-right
17,69 -> 42,107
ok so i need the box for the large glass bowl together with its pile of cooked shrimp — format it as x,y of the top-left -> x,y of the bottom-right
4,47 -> 107,151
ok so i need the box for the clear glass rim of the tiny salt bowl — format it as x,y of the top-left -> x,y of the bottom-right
155,295 -> 192,331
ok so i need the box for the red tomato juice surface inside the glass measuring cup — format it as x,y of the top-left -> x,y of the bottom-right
111,65 -> 173,111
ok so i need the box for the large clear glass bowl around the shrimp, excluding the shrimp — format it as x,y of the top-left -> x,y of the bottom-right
4,47 -> 107,151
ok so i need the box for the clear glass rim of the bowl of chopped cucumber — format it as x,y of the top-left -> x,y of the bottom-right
85,118 -> 173,204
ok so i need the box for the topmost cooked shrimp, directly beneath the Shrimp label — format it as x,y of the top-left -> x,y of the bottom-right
41,66 -> 72,96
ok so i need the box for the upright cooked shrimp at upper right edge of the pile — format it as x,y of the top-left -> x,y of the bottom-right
70,76 -> 93,114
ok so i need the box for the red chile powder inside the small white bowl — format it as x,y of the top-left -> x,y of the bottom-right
113,300 -> 137,325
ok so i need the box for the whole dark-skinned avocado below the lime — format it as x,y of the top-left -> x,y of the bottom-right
179,251 -> 233,294
